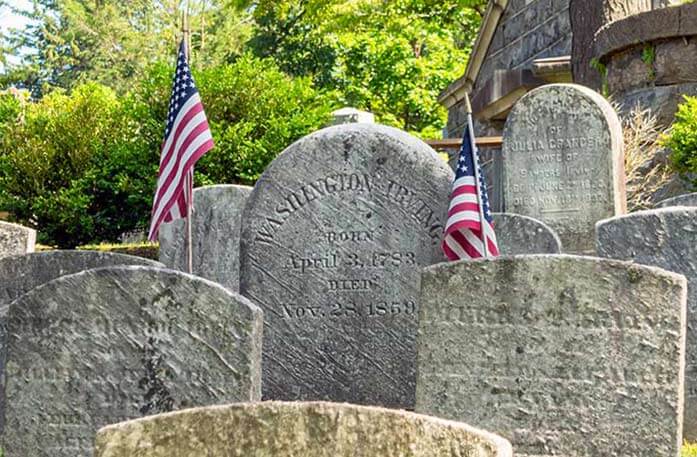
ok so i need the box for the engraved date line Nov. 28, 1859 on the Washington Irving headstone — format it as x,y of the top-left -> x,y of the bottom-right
281,300 -> 416,319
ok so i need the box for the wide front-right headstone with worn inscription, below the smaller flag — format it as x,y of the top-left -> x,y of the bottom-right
416,255 -> 686,457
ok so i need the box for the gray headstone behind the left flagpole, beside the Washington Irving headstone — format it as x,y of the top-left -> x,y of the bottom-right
159,185 -> 252,291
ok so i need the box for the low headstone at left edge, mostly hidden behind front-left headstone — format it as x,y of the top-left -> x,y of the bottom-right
0,251 -> 162,306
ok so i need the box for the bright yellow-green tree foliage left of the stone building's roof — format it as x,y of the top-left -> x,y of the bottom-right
249,0 -> 485,137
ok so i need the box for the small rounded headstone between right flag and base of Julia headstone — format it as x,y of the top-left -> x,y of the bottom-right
493,213 -> 561,256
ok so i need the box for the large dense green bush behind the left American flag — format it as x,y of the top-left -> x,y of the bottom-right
0,56 -> 330,248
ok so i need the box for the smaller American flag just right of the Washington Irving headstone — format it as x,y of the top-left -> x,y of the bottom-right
441,114 -> 499,260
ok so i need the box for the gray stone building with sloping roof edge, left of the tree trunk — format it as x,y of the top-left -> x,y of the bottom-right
439,0 -> 571,138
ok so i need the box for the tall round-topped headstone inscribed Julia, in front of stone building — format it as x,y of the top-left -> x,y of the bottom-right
503,84 -> 627,253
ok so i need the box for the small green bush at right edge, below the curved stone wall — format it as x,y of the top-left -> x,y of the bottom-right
665,96 -> 697,185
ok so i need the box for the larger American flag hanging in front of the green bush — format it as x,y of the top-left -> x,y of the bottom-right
148,41 -> 213,241
